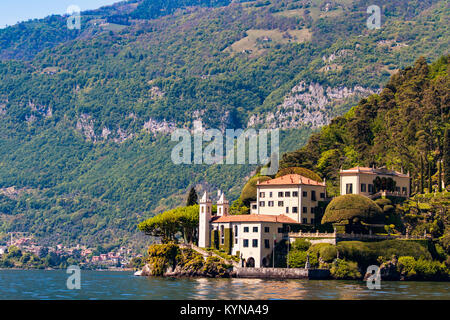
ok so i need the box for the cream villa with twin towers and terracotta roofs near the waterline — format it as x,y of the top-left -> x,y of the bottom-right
199,174 -> 326,268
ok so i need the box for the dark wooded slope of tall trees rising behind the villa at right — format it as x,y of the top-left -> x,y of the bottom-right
280,56 -> 450,193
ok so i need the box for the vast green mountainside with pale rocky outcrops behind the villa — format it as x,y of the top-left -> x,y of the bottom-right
0,0 -> 449,249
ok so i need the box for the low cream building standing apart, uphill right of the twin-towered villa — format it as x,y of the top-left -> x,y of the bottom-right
339,167 -> 411,198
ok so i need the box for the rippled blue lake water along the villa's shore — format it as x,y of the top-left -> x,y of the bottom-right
0,270 -> 450,300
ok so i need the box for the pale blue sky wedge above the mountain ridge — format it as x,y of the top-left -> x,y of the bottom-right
0,0 -> 123,28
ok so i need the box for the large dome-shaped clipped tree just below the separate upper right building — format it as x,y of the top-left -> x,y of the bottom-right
322,194 -> 383,224
